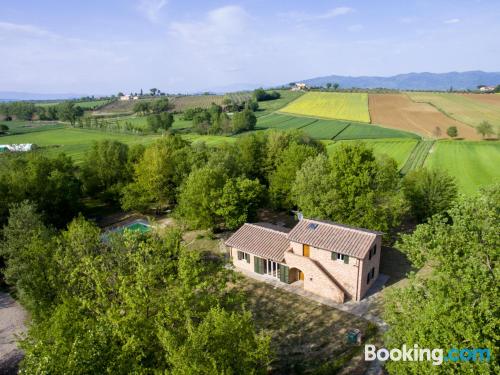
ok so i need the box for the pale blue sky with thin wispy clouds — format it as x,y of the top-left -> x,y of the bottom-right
0,0 -> 500,95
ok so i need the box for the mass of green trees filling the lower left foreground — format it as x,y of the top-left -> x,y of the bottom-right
0,202 -> 270,374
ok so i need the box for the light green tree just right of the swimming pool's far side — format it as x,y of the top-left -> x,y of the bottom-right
121,135 -> 191,210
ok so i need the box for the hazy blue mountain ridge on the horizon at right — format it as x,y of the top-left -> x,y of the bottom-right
297,71 -> 500,91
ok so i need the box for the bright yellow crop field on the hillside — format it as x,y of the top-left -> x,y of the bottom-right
280,92 -> 370,122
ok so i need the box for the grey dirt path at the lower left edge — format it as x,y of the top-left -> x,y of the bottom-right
0,292 -> 27,374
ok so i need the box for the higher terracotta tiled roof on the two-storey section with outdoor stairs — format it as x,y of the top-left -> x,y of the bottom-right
288,219 -> 382,259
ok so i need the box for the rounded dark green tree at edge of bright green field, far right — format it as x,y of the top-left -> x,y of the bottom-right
402,168 -> 458,222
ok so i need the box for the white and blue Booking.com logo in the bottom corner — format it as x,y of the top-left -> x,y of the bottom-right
365,344 -> 490,366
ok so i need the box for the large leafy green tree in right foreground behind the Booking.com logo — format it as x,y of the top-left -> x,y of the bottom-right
384,185 -> 500,374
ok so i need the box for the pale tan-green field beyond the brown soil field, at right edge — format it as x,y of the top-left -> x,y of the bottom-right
408,92 -> 500,126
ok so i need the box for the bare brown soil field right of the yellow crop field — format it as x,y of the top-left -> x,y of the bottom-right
368,94 -> 481,139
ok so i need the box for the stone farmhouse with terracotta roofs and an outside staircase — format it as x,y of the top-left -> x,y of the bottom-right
225,219 -> 382,303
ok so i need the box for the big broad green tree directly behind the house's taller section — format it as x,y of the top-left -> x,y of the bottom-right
292,143 -> 406,232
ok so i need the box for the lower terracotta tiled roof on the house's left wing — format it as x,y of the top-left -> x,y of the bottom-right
225,224 -> 290,262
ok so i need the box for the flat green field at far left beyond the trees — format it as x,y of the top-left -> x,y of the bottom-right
0,128 -> 158,163
